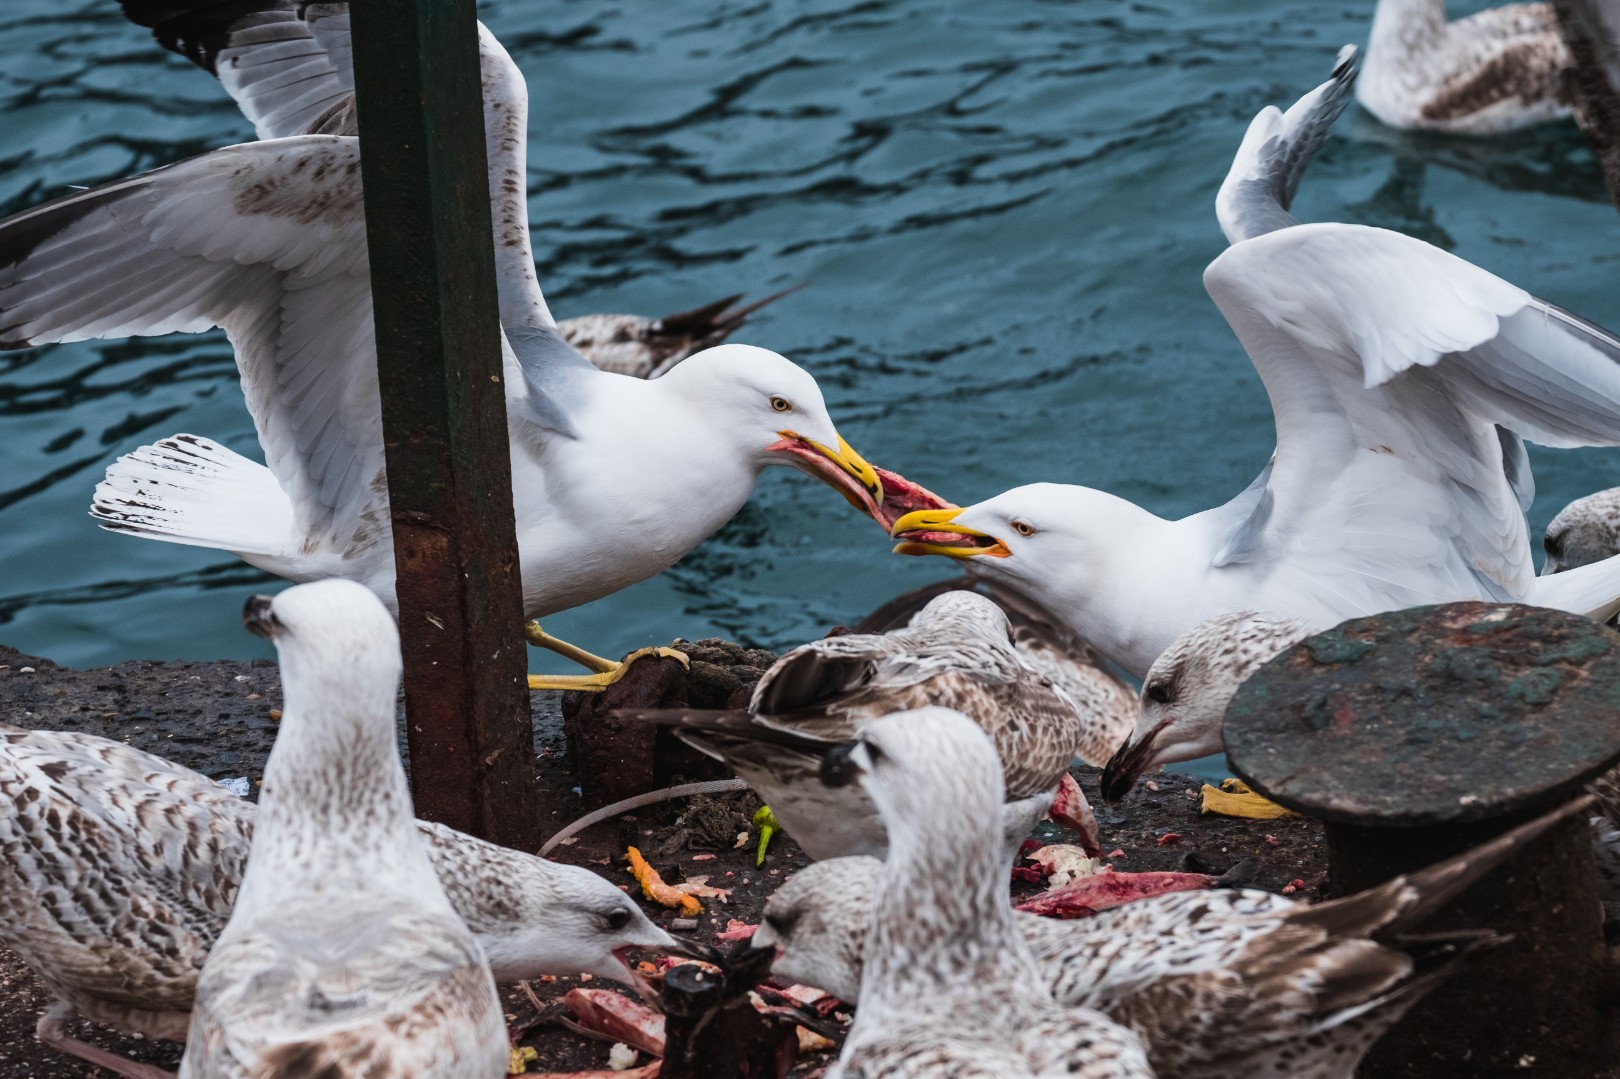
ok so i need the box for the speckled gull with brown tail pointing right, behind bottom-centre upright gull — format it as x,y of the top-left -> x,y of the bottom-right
753,802 -> 1568,1079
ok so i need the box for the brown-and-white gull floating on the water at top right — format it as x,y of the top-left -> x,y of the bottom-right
1356,0 -> 1571,134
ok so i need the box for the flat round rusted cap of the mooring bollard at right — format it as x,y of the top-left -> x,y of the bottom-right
1225,603 -> 1620,826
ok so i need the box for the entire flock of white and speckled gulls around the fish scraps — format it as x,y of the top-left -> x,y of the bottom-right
0,0 -> 1620,1079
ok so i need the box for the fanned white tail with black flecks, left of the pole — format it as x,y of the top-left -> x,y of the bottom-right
91,434 -> 293,556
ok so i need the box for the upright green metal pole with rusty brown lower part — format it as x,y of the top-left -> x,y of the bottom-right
350,0 -> 541,849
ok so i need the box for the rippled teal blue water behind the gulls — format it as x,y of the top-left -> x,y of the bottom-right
0,0 -> 1620,669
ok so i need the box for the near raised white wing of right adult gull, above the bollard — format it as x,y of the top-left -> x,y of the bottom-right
1204,224 -> 1620,609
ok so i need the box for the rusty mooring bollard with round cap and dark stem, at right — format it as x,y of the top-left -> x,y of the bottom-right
1223,603 -> 1620,1079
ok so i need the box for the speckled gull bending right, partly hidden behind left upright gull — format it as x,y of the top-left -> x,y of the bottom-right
0,724 -> 682,1079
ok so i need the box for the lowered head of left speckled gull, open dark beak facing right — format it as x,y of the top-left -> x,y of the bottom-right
465,852 -> 690,995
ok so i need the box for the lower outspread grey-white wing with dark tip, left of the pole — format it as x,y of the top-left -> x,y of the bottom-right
0,134 -> 386,549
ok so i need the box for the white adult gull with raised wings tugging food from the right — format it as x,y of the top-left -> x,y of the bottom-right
893,49 -> 1620,677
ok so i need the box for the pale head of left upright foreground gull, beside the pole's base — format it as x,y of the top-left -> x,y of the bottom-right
241,578 -> 403,726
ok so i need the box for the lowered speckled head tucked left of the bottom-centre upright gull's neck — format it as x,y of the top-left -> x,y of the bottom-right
750,855 -> 883,1004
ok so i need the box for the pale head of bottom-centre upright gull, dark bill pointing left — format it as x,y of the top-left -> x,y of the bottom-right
821,706 -> 1006,855
